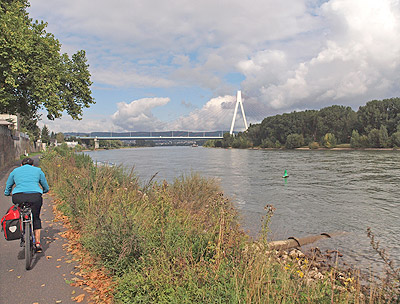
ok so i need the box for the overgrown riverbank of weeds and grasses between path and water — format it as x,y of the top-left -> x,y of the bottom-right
36,146 -> 400,303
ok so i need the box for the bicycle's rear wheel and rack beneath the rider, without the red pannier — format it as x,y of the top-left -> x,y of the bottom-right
19,203 -> 36,270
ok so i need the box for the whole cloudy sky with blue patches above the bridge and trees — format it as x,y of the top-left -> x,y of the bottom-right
28,0 -> 400,133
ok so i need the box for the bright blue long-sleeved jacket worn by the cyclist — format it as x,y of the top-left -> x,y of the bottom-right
4,165 -> 49,196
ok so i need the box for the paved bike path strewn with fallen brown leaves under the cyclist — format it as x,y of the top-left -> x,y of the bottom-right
0,159 -> 88,304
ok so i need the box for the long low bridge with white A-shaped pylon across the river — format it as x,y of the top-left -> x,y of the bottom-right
76,91 -> 248,148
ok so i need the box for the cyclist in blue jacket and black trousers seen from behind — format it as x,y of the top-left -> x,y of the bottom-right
4,158 -> 49,252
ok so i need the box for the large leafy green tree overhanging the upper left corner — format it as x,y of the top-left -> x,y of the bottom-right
0,0 -> 94,121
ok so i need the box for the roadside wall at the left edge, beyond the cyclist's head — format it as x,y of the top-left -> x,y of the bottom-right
0,126 -> 38,170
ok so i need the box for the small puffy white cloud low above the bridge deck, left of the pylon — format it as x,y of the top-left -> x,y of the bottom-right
111,97 -> 170,131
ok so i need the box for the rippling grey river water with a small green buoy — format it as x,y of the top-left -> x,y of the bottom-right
87,147 -> 400,271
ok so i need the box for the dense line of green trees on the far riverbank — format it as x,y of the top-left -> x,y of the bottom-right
205,98 -> 400,149
